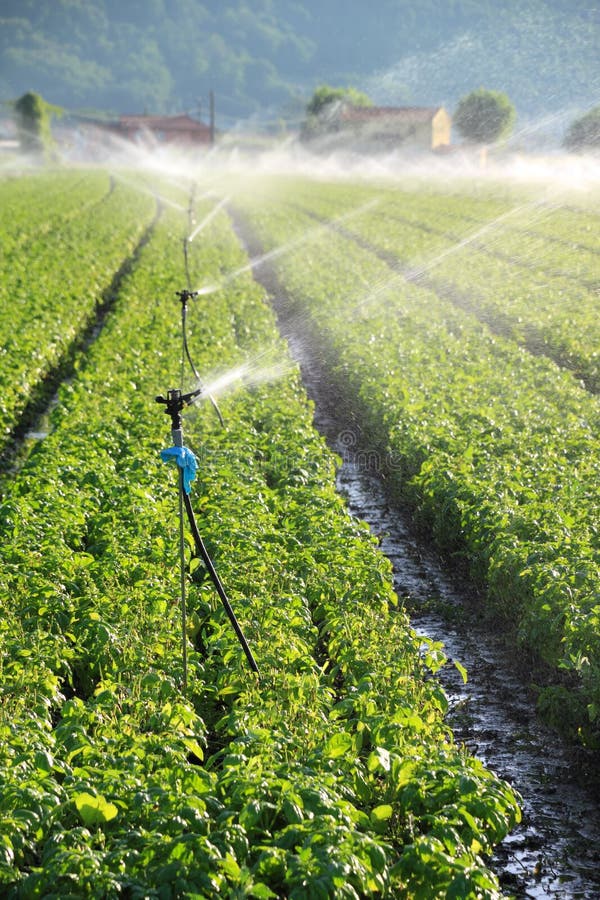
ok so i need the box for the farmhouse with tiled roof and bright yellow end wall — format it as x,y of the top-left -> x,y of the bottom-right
314,103 -> 452,153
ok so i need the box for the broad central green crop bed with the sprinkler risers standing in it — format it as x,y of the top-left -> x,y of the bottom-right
0,172 -> 519,898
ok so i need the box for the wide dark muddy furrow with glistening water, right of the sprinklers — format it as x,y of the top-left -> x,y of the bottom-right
286,334 -> 600,900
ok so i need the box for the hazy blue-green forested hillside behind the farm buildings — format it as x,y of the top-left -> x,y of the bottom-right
0,0 -> 600,133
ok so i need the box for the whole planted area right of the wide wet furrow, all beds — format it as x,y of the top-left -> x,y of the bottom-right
226,174 -> 600,746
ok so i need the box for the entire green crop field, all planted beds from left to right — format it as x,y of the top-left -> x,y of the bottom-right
0,163 -> 600,898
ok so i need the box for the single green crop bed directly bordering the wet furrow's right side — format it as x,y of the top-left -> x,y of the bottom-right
229,183 -> 600,745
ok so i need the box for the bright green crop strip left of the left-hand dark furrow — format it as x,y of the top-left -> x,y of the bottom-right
0,172 -> 156,449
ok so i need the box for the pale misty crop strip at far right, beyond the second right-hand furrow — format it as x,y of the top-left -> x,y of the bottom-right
274,182 -> 600,393
